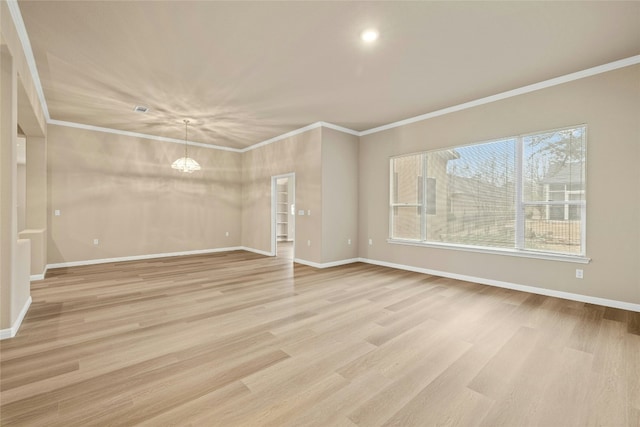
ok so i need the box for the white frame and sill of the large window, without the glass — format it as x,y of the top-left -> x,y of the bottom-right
387,123 -> 591,264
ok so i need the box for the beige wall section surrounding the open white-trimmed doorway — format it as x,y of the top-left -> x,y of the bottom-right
242,128 -> 322,263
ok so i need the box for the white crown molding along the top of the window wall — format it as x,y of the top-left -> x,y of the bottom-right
360,55 -> 640,136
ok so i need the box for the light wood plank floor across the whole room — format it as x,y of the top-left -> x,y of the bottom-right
0,251 -> 640,426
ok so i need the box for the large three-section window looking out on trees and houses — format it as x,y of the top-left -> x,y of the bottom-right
390,126 -> 586,256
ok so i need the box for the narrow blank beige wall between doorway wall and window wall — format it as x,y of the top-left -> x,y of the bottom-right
322,127 -> 359,263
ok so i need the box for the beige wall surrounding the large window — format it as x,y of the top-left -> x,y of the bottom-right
359,66 -> 640,304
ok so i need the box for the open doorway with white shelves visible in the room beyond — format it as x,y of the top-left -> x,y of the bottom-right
271,173 -> 296,260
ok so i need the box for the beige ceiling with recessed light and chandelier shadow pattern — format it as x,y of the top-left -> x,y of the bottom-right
18,1 -> 640,149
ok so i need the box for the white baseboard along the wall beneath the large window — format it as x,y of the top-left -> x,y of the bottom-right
358,258 -> 640,312
